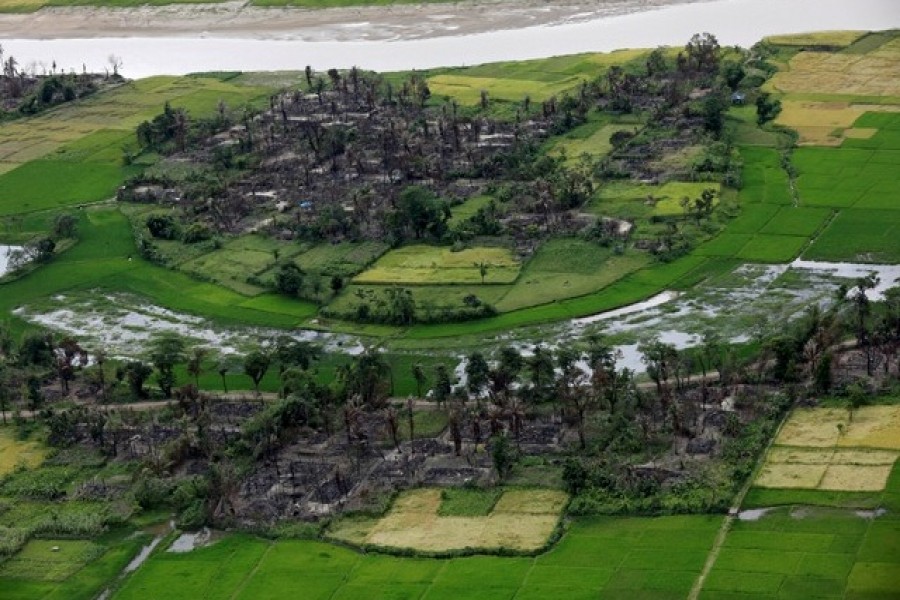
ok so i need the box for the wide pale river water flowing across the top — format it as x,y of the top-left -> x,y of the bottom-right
3,0 -> 900,78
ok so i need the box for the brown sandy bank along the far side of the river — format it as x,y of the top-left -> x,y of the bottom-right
0,0 -> 710,41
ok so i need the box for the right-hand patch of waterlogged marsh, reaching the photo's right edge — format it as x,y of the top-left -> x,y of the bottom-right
457,260 -> 900,373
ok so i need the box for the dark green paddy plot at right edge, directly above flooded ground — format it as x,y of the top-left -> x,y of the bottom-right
804,208 -> 900,263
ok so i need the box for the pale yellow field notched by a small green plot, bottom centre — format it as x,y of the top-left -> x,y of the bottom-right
331,488 -> 567,552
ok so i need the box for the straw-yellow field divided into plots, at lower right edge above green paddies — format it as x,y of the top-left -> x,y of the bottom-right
755,406 -> 900,492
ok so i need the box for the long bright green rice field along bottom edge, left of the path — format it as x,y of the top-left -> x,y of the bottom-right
114,516 -> 721,600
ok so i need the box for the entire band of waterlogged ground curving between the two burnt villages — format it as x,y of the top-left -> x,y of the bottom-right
15,260 -> 900,372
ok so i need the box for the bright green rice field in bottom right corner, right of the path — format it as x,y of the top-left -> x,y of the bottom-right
700,463 -> 900,600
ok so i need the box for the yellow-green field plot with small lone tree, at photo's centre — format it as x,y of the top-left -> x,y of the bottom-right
354,246 -> 520,285
